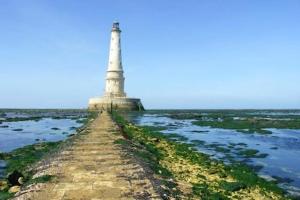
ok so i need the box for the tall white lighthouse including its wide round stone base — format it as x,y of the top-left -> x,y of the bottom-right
89,22 -> 144,110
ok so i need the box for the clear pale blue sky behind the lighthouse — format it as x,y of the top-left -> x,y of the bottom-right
0,0 -> 300,108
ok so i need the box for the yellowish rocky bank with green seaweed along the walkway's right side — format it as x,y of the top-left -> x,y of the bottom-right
114,113 -> 291,199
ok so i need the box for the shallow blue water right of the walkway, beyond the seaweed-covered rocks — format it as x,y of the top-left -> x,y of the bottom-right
128,111 -> 300,195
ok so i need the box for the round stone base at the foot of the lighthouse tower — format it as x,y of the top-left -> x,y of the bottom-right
88,96 -> 144,111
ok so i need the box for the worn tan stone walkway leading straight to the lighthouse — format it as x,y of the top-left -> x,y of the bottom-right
15,113 -> 160,200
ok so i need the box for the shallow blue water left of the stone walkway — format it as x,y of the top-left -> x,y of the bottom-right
0,110 -> 86,177
